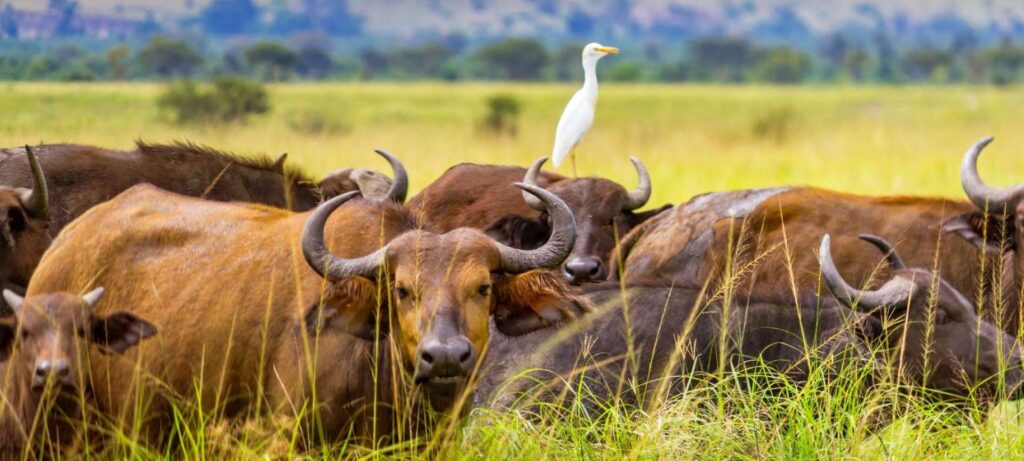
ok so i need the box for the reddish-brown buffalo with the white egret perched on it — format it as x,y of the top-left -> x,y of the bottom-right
409,157 -> 668,284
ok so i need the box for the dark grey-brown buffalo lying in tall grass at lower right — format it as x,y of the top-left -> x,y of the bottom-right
475,236 -> 1024,406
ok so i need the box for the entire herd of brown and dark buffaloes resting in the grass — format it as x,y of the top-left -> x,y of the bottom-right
0,138 -> 1024,452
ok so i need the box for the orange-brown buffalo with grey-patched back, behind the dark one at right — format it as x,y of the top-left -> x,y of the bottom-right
611,140 -> 1020,335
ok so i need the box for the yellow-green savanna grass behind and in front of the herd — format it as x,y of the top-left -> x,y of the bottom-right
6,83 -> 1024,460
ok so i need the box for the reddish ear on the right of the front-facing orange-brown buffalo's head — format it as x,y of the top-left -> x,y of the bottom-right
494,270 -> 592,336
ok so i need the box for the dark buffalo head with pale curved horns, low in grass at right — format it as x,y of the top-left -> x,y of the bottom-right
819,235 -> 1024,395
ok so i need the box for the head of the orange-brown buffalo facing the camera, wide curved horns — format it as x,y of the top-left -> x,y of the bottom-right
302,184 -> 587,410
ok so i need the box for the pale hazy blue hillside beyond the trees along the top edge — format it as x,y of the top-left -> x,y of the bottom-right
0,0 -> 1024,47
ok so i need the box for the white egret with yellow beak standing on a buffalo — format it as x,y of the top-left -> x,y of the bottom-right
551,43 -> 618,175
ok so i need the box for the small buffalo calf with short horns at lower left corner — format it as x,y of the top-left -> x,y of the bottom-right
0,288 -> 157,459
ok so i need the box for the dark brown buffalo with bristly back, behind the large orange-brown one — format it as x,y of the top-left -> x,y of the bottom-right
0,142 -> 399,309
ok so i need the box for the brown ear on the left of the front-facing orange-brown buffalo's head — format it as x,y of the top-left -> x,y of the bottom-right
305,277 -> 388,341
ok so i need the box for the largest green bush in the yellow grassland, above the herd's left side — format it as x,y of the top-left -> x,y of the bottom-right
157,77 -> 270,124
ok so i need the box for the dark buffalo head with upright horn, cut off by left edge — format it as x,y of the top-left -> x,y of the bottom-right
0,145 -> 51,301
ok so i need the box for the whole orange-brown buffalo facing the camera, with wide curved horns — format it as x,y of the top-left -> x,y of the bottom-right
22,152 -> 586,446
